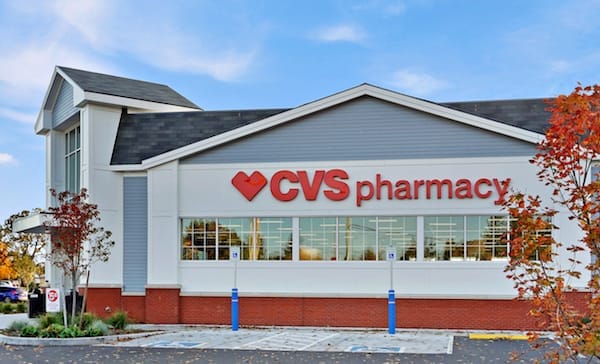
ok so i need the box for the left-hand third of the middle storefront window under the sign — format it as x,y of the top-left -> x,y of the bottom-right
300,217 -> 337,260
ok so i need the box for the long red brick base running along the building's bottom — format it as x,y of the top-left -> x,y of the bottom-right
82,288 -> 584,330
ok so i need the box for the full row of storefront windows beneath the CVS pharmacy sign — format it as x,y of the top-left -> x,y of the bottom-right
181,215 -> 552,261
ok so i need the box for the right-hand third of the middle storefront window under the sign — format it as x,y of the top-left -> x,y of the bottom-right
377,216 -> 417,260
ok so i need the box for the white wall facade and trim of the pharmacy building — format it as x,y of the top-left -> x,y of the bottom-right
30,66 -> 586,310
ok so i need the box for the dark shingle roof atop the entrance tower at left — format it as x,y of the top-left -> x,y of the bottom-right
58,66 -> 200,109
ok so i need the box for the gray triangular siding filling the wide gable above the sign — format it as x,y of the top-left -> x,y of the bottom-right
182,97 -> 536,164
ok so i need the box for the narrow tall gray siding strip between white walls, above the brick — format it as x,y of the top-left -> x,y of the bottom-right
123,177 -> 148,292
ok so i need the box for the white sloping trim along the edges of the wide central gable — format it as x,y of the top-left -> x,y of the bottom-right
110,84 -> 544,170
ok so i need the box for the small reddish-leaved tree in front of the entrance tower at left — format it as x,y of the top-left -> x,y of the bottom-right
47,189 -> 115,322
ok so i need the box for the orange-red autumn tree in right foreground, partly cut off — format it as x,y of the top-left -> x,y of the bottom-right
505,85 -> 600,362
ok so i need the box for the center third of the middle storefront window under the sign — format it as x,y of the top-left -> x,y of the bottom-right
338,217 -> 377,260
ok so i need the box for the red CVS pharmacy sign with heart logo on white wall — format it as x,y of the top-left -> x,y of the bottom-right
231,169 -> 510,207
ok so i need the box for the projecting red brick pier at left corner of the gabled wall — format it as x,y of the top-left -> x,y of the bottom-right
145,288 -> 180,324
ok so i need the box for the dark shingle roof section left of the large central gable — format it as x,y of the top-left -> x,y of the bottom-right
111,109 -> 288,165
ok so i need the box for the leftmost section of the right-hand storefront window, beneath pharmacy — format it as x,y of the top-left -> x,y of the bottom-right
424,216 -> 465,261
